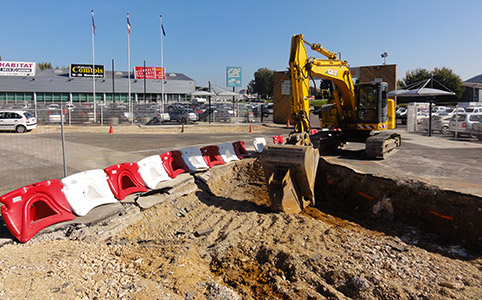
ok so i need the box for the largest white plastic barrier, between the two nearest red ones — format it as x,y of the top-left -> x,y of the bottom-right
61,169 -> 117,216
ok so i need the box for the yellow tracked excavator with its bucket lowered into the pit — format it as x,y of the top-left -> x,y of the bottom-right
261,34 -> 401,213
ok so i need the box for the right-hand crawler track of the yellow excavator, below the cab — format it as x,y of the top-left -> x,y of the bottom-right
365,132 -> 402,159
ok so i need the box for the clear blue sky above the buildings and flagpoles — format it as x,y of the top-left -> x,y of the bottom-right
0,0 -> 482,87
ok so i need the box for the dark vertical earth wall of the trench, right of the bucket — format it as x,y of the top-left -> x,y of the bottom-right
315,159 -> 482,251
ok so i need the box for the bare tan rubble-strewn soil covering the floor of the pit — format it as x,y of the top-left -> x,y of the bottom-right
0,159 -> 482,299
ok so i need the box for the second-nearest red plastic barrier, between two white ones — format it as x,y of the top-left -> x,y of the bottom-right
104,163 -> 147,200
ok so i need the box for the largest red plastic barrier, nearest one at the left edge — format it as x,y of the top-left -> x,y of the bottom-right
0,179 -> 75,243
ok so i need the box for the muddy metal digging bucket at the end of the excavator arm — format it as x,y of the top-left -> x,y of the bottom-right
261,145 -> 320,213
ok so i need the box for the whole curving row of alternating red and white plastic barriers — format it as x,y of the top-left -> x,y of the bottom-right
0,141 -> 249,243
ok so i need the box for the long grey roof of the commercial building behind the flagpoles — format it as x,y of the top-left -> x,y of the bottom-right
0,69 -> 196,94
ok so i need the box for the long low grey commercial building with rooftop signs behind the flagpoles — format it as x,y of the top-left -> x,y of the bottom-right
0,61 -> 195,106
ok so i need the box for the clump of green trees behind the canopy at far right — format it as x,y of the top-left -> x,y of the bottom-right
397,67 -> 465,99
